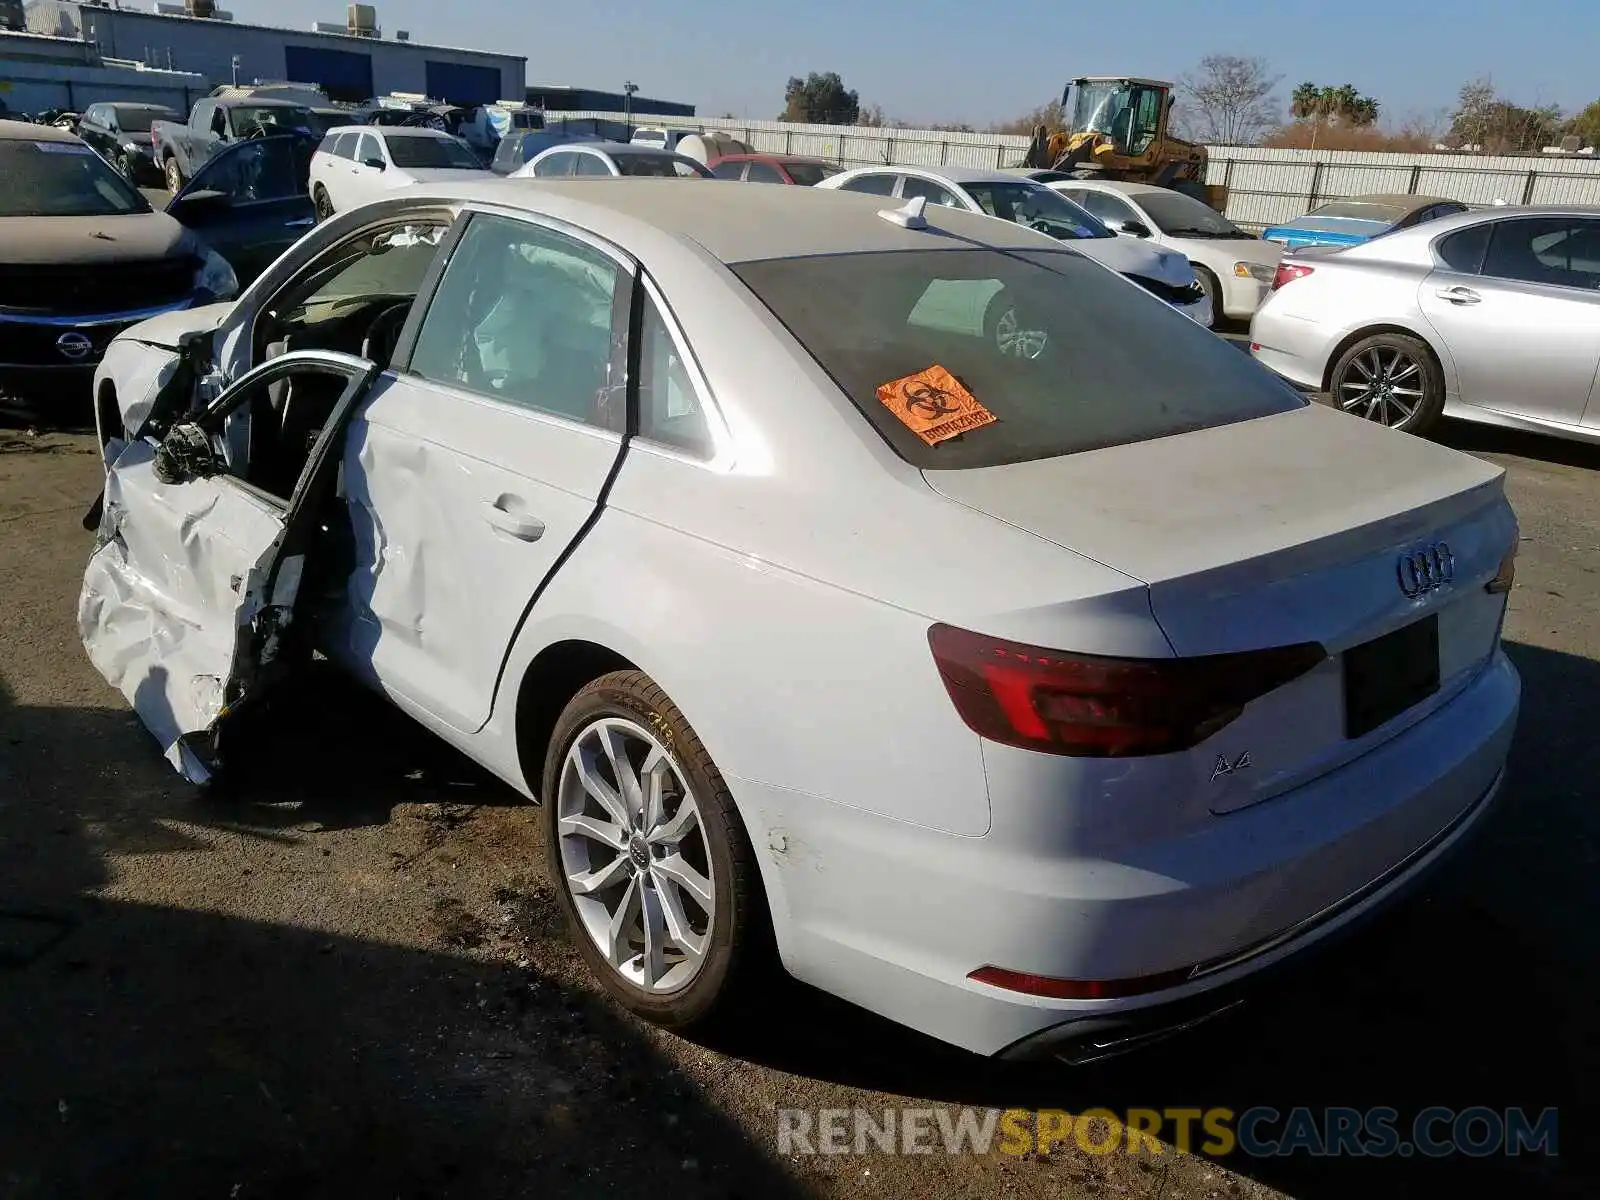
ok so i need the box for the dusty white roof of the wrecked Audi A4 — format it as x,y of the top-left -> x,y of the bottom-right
416,176 -> 1064,262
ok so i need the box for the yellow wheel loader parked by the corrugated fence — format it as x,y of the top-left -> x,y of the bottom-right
1022,75 -> 1227,213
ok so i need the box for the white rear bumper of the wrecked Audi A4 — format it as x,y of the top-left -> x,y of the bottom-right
755,651 -> 1520,1061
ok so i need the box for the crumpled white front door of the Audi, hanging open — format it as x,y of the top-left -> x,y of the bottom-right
78,350 -> 379,784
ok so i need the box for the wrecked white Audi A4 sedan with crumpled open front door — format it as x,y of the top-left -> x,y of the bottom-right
80,179 -> 1518,1061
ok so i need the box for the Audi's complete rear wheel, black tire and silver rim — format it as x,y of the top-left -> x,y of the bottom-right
539,670 -> 771,1032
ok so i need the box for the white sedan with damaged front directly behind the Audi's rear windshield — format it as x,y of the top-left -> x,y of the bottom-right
816,166 -> 1211,326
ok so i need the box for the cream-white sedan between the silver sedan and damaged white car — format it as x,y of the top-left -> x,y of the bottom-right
1046,179 -> 1283,320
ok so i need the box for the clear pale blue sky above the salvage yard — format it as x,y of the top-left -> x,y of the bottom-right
259,0 -> 1600,128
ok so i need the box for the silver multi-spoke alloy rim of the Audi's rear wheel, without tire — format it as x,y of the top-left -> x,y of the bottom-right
555,717 -> 717,994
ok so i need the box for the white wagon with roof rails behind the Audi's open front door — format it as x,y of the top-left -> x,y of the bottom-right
309,125 -> 490,221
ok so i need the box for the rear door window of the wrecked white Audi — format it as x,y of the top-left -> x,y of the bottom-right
411,214 -> 622,427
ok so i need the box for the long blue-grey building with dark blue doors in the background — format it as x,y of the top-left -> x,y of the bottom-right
27,0 -> 528,104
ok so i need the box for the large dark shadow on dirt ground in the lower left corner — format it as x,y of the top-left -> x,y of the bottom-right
0,683 -> 798,1200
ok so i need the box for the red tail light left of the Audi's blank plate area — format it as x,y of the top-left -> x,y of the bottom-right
928,626 -> 1328,758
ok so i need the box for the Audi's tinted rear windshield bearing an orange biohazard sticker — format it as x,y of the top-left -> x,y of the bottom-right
733,248 -> 1306,469
